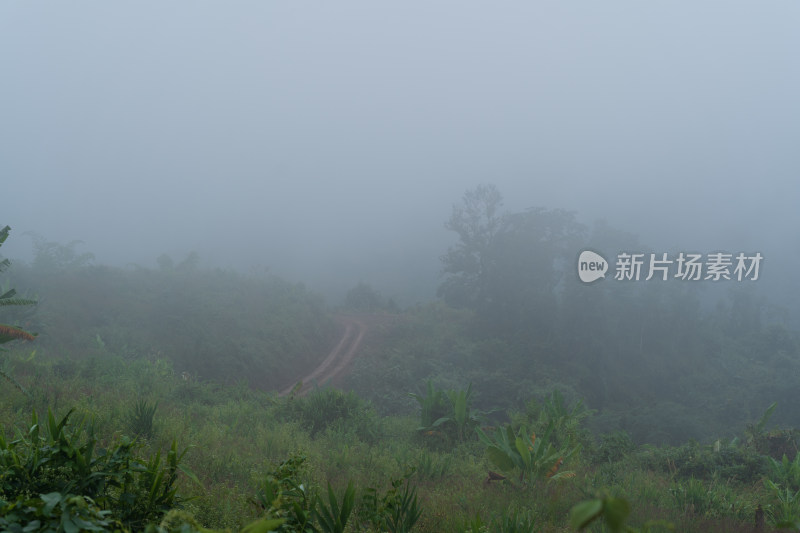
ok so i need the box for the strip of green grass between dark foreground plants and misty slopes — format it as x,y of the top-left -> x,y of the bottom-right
0,353 -> 780,532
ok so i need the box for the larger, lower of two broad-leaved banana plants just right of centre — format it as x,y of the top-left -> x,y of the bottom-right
475,422 -> 580,483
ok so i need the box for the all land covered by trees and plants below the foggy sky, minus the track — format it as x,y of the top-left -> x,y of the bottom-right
0,185 -> 800,533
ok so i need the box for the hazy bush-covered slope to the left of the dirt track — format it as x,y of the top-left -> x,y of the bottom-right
3,251 -> 338,389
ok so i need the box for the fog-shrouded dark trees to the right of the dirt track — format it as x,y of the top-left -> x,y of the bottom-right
352,186 -> 800,442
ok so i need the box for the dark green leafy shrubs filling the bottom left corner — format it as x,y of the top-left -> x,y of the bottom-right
0,410 -> 199,531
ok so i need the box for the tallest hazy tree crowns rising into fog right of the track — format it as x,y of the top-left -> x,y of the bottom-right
439,185 -> 584,337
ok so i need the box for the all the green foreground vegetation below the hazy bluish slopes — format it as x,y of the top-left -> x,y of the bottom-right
7,342 -> 800,532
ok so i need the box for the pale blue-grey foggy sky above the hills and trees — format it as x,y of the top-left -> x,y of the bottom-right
0,1 -> 800,303
